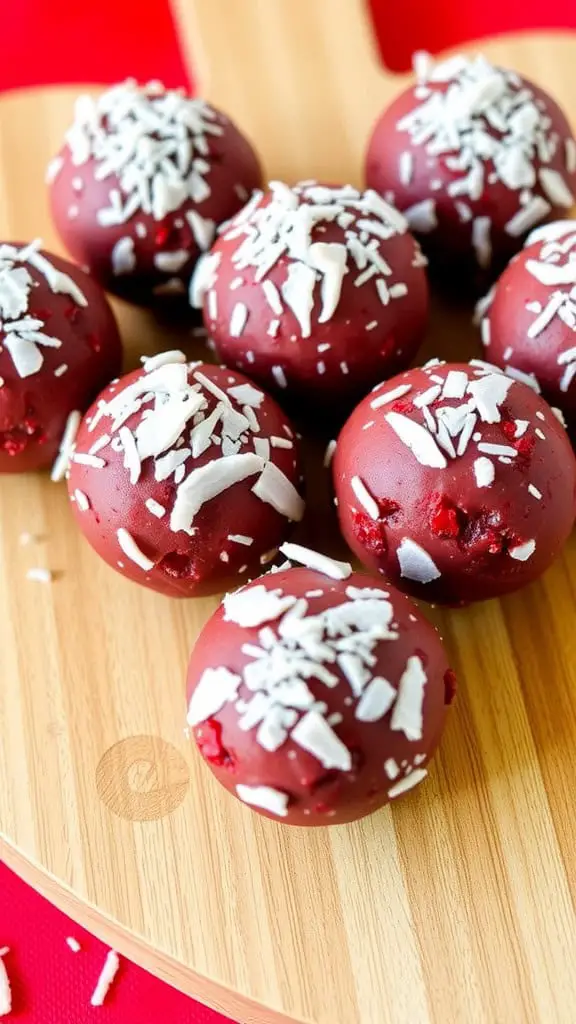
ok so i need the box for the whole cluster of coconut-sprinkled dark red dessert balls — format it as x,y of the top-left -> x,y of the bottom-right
0,54 -> 576,825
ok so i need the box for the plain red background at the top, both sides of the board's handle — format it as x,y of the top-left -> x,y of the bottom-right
0,0 -> 576,90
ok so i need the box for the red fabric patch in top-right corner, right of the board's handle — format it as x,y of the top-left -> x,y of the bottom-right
368,0 -> 576,73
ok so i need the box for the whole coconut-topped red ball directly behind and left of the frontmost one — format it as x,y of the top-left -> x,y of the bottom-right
69,352 -> 303,597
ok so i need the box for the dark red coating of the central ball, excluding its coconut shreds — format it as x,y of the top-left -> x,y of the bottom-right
203,184 -> 428,407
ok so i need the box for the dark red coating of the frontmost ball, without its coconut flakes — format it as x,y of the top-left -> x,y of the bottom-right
188,568 -> 455,825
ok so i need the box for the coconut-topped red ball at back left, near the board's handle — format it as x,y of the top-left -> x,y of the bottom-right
47,80 -> 261,304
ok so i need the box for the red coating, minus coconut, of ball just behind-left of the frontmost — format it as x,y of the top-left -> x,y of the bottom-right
69,364 -> 301,597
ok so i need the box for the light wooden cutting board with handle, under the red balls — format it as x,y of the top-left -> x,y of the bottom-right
0,0 -> 576,1024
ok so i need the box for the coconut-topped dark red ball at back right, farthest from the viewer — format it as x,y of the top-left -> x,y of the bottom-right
366,53 -> 576,286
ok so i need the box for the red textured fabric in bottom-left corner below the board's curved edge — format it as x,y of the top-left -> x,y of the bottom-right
0,863 -> 230,1024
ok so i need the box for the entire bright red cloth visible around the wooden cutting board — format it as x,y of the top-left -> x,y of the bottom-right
0,0 -> 576,1024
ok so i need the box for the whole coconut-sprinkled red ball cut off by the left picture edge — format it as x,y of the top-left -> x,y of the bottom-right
0,241 -> 122,480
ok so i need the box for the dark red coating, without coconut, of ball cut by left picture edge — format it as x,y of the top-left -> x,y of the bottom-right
0,249 -> 122,473
